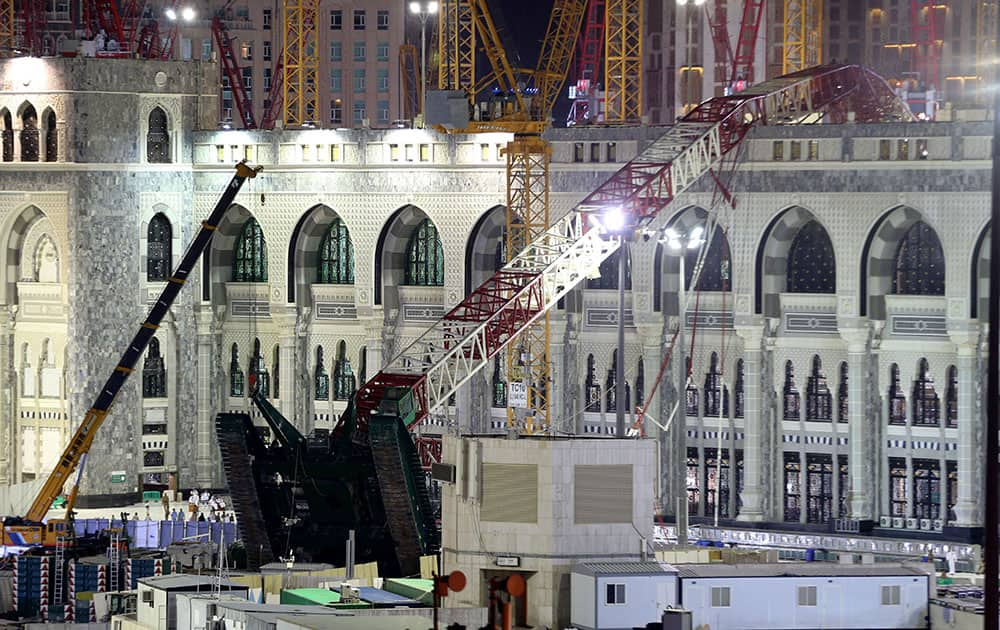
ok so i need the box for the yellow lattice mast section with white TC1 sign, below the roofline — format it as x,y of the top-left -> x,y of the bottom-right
506,135 -> 552,433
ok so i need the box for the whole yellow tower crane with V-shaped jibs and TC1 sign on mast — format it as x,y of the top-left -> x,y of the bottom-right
439,0 -> 586,433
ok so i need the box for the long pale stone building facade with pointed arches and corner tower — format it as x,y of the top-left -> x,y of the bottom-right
0,59 -> 990,536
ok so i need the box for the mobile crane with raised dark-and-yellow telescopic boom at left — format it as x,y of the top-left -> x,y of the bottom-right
3,162 -> 261,547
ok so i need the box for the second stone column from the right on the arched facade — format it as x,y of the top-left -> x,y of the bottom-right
840,325 -> 878,521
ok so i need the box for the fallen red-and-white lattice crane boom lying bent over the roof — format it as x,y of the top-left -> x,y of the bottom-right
344,66 -> 913,446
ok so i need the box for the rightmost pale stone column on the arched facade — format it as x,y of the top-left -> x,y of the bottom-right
941,321 -> 985,527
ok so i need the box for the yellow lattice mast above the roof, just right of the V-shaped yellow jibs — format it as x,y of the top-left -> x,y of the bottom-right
604,0 -> 643,123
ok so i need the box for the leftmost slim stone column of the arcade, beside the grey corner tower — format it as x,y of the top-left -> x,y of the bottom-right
195,305 -> 217,488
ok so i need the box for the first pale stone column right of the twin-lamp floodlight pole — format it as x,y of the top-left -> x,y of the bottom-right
736,325 -> 765,522
